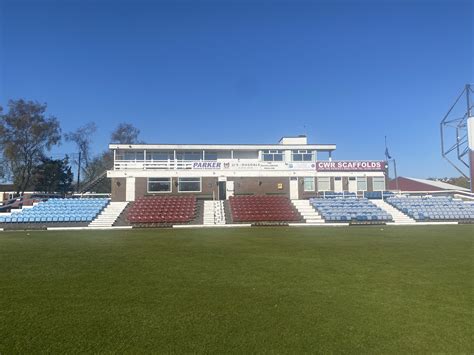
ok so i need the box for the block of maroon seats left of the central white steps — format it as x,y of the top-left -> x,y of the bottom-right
128,196 -> 196,223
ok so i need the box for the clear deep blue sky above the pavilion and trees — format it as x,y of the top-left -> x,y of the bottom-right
0,0 -> 474,177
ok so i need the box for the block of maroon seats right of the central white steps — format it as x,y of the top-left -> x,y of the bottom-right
229,196 -> 301,222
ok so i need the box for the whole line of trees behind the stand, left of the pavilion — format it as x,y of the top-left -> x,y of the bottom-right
0,99 -> 141,195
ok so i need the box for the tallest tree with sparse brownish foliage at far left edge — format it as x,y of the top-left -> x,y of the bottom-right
0,99 -> 61,194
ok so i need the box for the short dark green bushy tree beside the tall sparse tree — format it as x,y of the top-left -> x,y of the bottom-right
33,156 -> 73,194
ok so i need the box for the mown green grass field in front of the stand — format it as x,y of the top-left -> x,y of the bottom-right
0,225 -> 474,354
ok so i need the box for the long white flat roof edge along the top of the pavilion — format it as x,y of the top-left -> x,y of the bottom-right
109,143 -> 336,151
